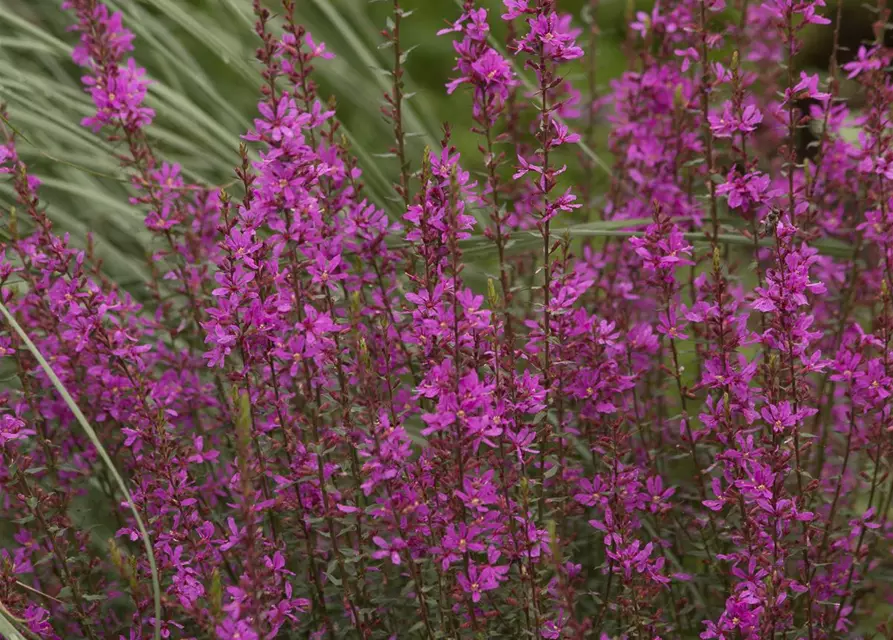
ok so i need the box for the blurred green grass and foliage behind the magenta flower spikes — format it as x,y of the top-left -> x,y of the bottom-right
0,0 -> 870,288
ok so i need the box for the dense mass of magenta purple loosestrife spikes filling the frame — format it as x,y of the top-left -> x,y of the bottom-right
0,0 -> 893,640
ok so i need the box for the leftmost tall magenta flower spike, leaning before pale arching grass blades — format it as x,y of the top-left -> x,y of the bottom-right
62,0 -> 220,335
